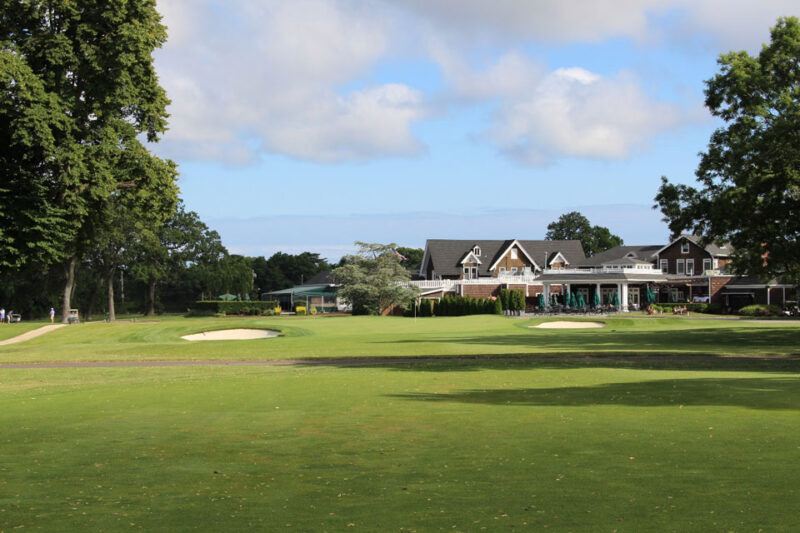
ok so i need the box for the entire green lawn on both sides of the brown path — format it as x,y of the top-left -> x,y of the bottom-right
0,317 -> 800,531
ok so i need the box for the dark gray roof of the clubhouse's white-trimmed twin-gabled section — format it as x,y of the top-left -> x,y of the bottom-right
423,239 -> 586,276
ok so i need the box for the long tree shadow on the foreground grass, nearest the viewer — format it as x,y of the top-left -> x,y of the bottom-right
390,377 -> 800,411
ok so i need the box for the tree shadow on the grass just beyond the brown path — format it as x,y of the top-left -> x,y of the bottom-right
376,327 -> 800,355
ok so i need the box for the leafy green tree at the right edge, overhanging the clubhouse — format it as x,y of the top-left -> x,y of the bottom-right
655,17 -> 800,281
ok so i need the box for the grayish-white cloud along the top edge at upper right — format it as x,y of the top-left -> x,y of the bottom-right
387,0 -> 800,50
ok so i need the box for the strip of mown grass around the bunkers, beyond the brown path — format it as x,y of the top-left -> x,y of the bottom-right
0,316 -> 800,362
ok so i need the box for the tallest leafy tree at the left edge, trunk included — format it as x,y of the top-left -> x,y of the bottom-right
0,0 -> 174,317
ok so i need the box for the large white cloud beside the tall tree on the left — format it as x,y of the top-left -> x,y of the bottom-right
157,0 -> 426,164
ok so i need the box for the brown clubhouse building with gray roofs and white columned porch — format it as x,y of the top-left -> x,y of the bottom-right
411,235 -> 795,311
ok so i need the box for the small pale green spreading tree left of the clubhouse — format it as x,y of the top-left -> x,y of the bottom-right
331,242 -> 418,315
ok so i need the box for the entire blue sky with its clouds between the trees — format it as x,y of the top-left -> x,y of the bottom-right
153,0 -> 800,260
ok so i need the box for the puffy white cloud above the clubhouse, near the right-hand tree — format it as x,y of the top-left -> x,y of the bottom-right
487,68 -> 681,165
